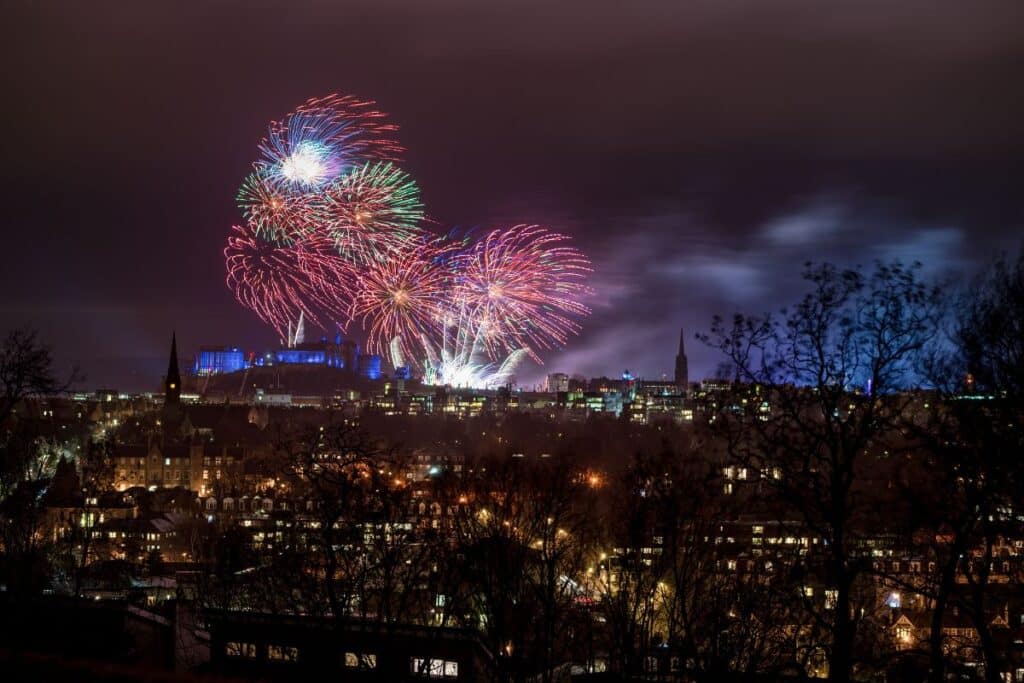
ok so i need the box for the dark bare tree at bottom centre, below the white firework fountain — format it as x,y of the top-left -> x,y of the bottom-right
451,457 -> 593,680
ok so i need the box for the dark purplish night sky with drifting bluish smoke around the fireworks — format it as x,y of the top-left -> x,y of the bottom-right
0,0 -> 1024,389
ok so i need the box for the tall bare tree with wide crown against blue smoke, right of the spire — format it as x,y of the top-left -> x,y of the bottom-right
702,263 -> 938,681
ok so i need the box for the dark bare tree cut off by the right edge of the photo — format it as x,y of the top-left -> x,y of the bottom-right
905,252 -> 1024,682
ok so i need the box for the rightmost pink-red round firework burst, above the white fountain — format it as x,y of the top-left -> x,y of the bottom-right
453,225 -> 591,362
